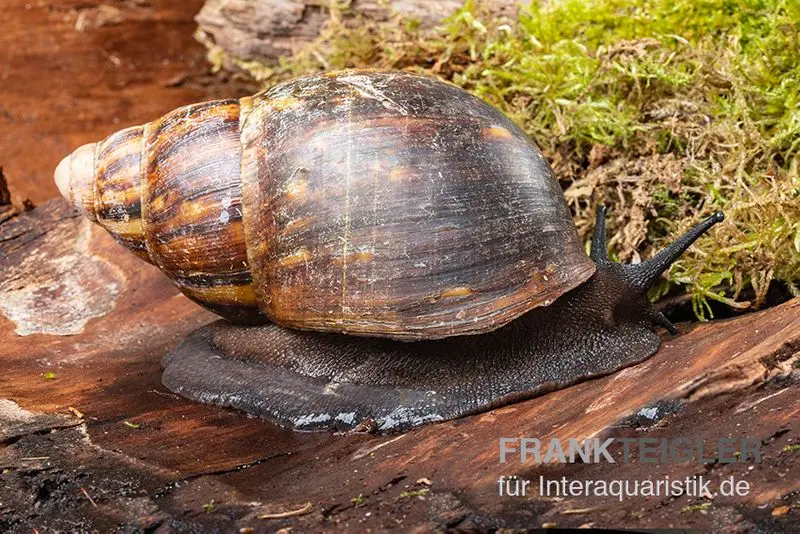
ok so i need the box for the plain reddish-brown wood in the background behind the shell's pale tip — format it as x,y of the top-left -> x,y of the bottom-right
0,0 -> 255,205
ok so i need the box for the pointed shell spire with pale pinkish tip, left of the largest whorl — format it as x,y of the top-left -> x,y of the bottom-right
56,100 -> 262,322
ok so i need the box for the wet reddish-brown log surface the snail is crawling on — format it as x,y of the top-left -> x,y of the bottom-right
0,201 -> 800,532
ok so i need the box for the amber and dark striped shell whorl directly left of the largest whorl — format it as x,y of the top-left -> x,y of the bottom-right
140,100 -> 260,321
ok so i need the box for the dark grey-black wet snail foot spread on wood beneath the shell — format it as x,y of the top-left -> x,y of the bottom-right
162,313 -> 658,432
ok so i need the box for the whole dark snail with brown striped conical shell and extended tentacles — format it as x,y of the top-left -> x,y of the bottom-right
55,71 -> 723,431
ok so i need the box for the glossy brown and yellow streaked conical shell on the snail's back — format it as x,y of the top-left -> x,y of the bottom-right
57,71 -> 595,339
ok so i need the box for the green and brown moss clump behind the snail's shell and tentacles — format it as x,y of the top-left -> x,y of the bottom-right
202,0 -> 800,319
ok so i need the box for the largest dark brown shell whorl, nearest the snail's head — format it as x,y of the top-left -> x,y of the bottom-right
240,71 -> 595,340
